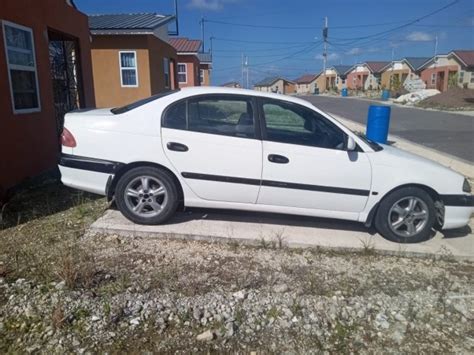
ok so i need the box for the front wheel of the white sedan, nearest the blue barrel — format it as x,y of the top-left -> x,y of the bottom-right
375,187 -> 436,243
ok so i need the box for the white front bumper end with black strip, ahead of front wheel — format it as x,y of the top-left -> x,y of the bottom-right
441,195 -> 474,229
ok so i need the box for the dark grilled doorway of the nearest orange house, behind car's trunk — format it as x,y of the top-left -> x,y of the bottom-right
48,31 -> 84,136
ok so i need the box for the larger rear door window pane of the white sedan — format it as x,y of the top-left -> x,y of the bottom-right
188,95 -> 255,138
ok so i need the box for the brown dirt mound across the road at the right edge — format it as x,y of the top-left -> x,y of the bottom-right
417,87 -> 474,111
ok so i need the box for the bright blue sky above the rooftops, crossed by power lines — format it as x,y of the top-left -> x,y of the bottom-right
75,0 -> 474,85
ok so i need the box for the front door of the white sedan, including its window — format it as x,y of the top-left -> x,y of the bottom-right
257,99 -> 371,212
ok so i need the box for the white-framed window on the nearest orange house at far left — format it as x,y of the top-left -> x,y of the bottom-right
3,21 -> 41,113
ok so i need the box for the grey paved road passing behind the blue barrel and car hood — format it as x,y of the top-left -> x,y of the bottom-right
304,96 -> 474,162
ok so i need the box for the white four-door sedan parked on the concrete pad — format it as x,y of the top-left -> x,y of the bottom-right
59,87 -> 474,243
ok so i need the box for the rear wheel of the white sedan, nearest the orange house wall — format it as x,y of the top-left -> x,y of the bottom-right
115,167 -> 179,225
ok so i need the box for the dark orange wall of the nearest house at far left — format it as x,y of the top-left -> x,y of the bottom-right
0,0 -> 95,198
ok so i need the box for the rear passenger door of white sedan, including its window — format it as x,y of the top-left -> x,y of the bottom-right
161,95 -> 262,203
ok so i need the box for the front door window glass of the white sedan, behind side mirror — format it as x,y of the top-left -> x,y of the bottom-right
262,99 -> 345,149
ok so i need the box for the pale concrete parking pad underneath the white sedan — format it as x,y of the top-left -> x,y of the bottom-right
89,209 -> 474,260
